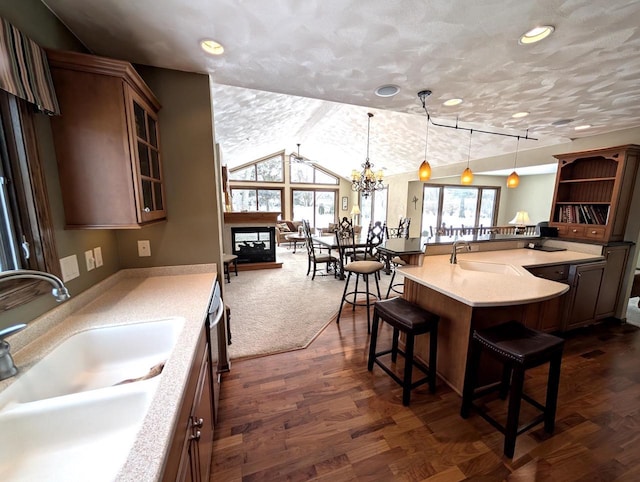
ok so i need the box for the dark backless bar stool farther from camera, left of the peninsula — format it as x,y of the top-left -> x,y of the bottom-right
367,298 -> 440,406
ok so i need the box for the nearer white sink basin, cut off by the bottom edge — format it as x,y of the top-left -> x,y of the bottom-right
0,377 -> 159,482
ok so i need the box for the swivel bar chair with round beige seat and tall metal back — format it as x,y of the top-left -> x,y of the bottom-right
336,230 -> 384,333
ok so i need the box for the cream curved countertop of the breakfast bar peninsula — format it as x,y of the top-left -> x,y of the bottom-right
400,248 -> 604,307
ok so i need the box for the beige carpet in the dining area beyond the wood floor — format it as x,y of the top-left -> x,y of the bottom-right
224,246 -> 398,360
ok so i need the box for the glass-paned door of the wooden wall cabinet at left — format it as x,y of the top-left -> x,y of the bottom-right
132,97 -> 165,221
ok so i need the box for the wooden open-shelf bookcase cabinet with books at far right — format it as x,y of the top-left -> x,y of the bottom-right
550,145 -> 640,243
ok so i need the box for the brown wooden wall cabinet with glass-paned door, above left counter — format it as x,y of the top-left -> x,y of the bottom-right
47,50 -> 166,229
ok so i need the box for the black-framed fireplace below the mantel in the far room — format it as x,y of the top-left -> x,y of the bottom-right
231,226 -> 276,264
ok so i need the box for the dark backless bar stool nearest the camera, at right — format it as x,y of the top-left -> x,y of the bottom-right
460,321 -> 564,458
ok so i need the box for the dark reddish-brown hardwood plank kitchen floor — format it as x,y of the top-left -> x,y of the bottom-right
211,309 -> 640,482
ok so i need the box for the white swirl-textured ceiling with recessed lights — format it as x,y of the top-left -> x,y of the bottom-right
45,0 -> 640,176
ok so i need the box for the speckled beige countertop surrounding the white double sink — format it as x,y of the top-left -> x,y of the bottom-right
0,264 -> 217,481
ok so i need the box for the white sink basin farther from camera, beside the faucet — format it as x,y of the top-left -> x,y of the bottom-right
0,317 -> 184,410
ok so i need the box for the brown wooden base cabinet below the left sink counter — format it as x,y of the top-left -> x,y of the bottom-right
162,328 -> 214,482
